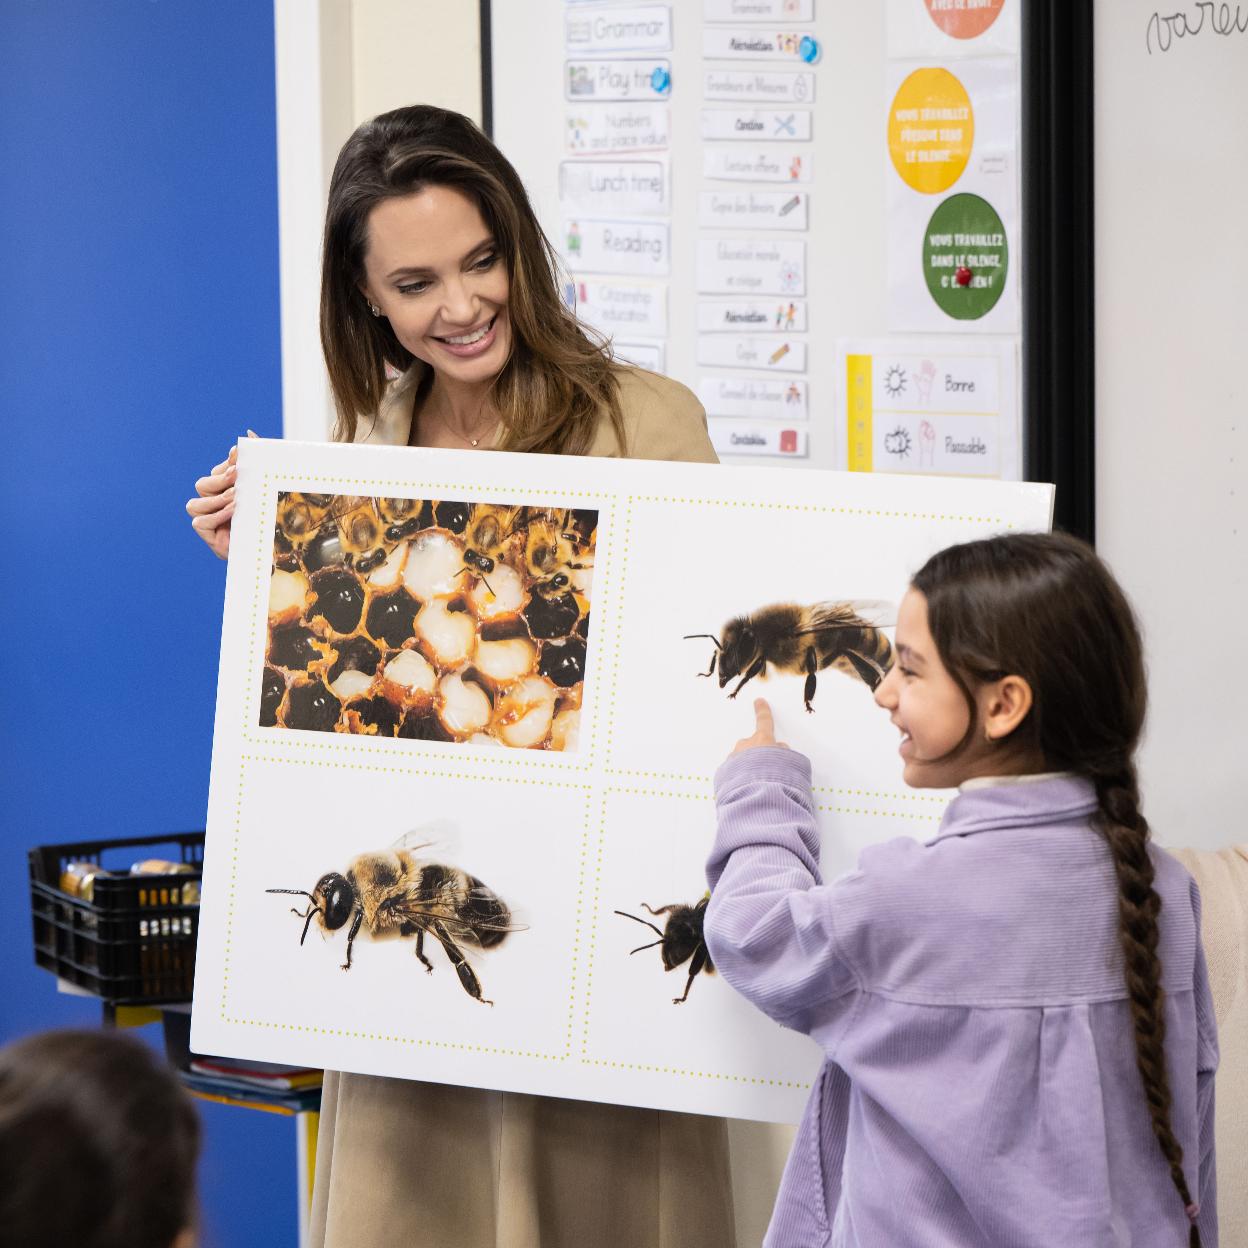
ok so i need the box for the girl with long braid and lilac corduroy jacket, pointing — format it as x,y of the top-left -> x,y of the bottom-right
706,534 -> 1217,1248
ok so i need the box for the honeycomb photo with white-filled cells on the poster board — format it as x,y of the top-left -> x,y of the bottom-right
260,493 -> 598,750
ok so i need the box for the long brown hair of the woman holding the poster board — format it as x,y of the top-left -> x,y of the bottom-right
321,105 -> 624,454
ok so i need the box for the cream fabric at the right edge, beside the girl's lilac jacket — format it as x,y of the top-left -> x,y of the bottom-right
1171,844 -> 1248,1248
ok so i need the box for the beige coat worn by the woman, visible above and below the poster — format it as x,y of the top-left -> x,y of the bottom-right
311,368 -> 736,1248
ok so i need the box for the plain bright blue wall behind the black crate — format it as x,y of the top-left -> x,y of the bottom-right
0,0 -> 296,1248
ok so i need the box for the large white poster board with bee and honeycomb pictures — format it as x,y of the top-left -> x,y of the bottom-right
192,441 -> 1051,1121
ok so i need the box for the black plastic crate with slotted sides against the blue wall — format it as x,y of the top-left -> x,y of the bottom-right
30,832 -> 203,1005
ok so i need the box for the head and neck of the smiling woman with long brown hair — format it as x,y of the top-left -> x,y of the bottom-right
321,106 -> 658,458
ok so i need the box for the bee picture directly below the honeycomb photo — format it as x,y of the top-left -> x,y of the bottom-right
265,846 -> 522,1006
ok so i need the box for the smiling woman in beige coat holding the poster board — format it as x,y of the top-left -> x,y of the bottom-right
187,106 -> 735,1248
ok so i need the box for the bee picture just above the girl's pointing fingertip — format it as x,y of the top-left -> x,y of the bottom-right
685,602 -> 894,711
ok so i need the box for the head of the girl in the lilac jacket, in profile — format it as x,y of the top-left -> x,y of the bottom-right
876,533 -> 1144,792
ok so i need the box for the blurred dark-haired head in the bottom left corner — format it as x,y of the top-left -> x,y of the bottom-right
0,1031 -> 200,1248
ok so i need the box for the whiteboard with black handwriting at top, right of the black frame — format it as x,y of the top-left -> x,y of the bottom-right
1093,0 -> 1248,849
